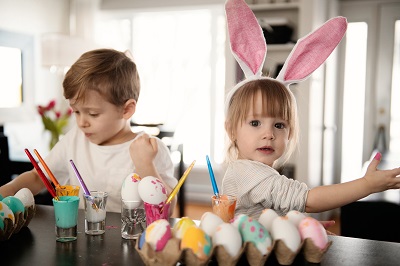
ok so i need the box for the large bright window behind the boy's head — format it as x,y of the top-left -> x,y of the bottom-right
97,6 -> 226,164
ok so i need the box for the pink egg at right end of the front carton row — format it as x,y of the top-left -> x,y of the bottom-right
299,217 -> 328,249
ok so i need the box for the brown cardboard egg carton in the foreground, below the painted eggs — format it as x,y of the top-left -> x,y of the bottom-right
135,236 -> 332,266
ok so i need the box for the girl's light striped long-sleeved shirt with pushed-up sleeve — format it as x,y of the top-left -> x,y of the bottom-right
222,160 -> 310,219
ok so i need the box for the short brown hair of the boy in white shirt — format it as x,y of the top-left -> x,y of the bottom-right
63,49 -> 140,106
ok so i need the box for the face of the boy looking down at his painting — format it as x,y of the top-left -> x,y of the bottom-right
70,90 -> 131,145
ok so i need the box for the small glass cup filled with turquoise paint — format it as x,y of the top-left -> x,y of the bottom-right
53,196 -> 79,242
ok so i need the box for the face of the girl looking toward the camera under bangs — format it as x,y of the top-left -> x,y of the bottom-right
234,93 -> 290,167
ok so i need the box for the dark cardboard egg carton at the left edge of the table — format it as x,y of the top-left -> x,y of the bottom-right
0,206 -> 36,241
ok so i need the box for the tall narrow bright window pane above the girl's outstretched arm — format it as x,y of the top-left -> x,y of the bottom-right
341,22 -> 368,182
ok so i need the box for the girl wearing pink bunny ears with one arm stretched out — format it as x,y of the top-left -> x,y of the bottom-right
222,0 -> 400,219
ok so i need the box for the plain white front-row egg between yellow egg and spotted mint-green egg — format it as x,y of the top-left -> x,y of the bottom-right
211,223 -> 242,257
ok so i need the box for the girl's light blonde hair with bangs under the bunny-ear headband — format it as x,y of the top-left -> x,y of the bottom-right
225,78 -> 299,167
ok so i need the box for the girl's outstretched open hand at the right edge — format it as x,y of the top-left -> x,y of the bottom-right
364,152 -> 400,193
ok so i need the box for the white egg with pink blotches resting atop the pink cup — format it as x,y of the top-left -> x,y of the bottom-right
138,176 -> 167,205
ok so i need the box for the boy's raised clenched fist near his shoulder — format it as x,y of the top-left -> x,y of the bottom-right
129,134 -> 158,167
